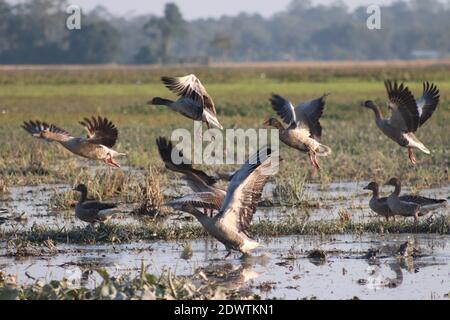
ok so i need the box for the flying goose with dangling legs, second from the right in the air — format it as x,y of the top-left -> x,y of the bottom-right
263,94 -> 331,170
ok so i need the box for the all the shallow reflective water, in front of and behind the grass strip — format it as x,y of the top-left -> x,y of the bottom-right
0,182 -> 450,299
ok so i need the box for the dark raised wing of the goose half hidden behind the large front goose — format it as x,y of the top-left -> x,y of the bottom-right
156,137 -> 217,191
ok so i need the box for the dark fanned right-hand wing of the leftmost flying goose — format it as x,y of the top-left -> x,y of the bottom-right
80,117 -> 119,148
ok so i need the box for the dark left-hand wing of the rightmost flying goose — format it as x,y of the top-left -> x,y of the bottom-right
384,80 -> 420,132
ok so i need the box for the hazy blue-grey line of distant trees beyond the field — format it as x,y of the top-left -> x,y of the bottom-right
0,0 -> 450,64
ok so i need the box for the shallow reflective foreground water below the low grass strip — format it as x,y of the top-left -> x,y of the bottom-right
0,234 -> 450,299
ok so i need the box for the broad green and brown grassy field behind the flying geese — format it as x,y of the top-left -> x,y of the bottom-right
0,64 -> 450,195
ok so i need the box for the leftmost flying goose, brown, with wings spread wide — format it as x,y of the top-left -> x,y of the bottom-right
22,117 -> 125,168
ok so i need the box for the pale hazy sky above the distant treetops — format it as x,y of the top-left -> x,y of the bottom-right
9,0 -> 400,20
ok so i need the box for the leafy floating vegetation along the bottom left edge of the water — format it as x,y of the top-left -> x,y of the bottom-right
0,265 -> 259,300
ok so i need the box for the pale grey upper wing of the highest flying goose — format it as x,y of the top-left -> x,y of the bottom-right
161,74 -> 216,116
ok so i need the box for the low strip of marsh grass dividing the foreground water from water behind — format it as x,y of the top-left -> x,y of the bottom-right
1,216 -> 450,244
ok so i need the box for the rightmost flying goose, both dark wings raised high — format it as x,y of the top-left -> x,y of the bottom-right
364,80 -> 440,165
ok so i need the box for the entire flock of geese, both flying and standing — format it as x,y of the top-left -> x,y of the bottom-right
14,74 -> 446,253
